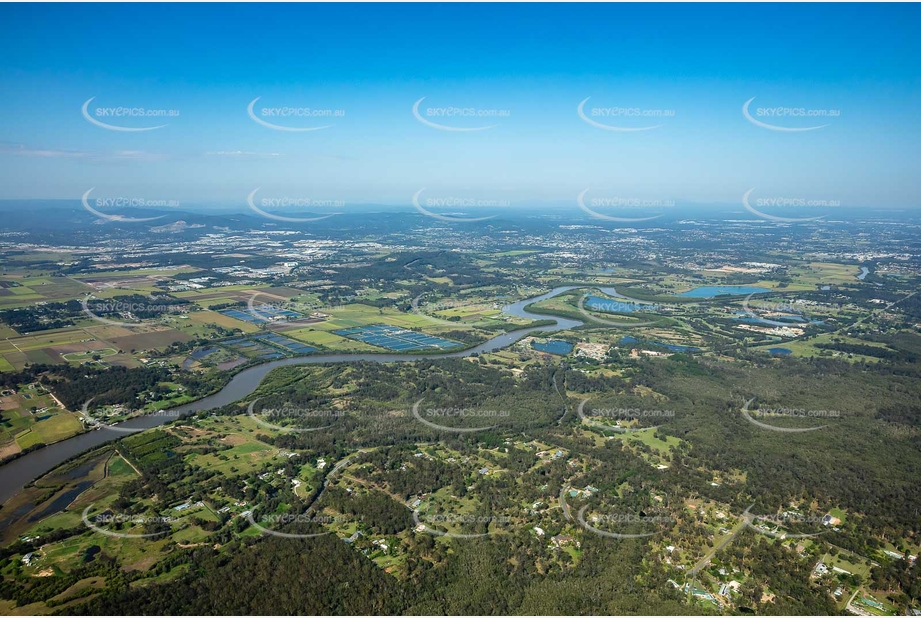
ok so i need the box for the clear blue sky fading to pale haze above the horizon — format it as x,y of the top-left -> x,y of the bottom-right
0,4 -> 921,208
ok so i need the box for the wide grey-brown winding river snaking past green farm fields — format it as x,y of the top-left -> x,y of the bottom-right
0,285 -> 585,504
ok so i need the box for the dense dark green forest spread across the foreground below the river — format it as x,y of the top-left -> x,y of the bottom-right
3,346 -> 908,615
